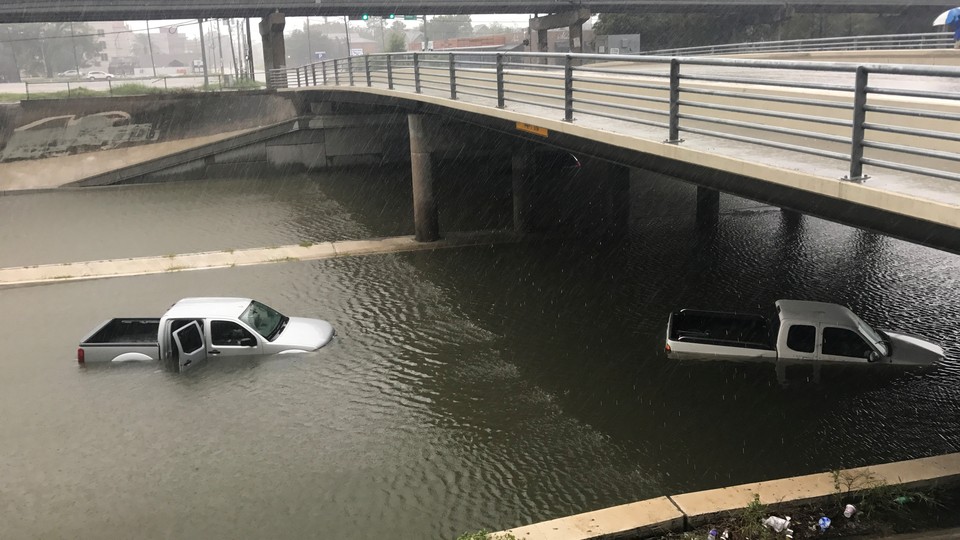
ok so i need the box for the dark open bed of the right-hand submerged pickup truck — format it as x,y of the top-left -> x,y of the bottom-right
667,309 -> 776,360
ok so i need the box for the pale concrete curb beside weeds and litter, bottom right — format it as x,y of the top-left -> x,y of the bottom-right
491,453 -> 960,540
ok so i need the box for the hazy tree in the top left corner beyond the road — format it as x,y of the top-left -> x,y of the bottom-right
0,23 -> 101,77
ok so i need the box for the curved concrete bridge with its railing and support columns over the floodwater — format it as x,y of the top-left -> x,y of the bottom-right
246,51 -> 960,253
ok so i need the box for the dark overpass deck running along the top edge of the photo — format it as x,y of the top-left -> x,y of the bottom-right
0,0 -> 954,23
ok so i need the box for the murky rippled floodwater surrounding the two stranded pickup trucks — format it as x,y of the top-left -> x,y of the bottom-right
0,169 -> 960,539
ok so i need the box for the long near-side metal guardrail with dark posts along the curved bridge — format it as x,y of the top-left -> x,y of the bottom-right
268,51 -> 960,186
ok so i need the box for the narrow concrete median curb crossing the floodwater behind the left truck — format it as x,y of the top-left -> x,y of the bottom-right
0,231 -> 520,287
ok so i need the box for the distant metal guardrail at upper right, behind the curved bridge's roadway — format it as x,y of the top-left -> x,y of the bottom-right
640,32 -> 953,56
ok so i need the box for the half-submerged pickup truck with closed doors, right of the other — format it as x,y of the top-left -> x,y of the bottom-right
666,300 -> 943,371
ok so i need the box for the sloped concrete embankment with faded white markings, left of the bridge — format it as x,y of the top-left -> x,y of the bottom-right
0,93 -> 409,191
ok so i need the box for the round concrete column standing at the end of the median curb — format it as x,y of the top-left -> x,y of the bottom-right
407,114 -> 440,242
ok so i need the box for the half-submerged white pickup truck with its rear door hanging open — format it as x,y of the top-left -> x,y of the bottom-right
77,298 -> 334,371
